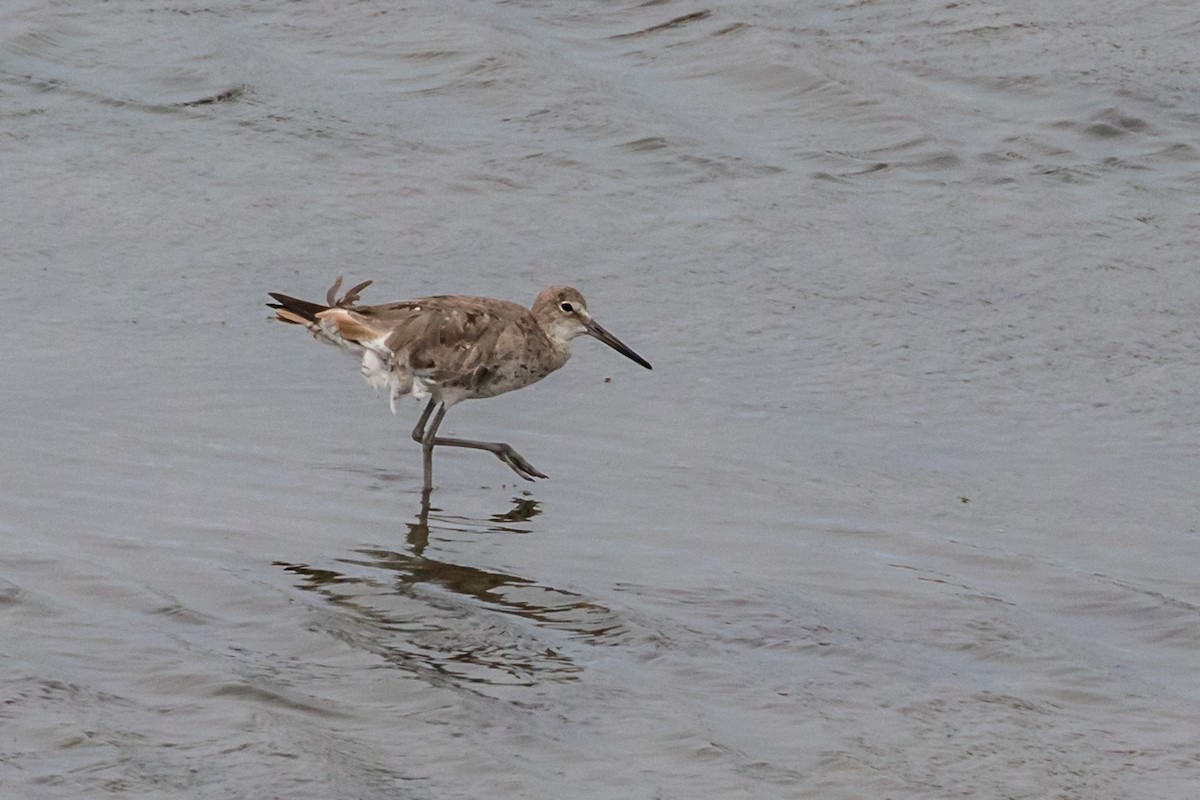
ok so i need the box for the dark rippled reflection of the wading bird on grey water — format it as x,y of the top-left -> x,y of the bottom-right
275,495 -> 628,693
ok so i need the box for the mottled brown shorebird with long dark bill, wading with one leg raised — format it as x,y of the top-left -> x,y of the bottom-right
266,277 -> 652,494
